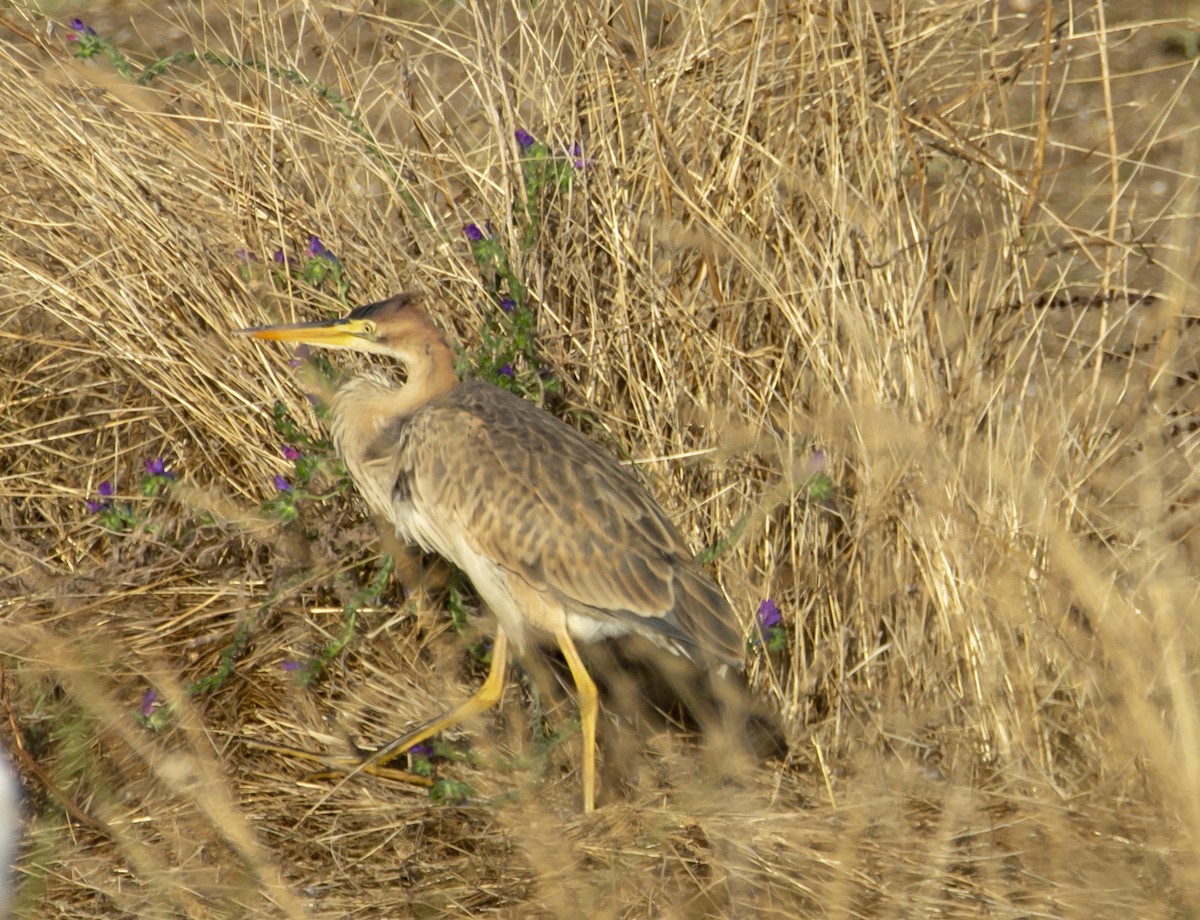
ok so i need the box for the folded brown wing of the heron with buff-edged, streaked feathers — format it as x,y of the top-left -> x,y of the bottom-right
402,383 -> 743,665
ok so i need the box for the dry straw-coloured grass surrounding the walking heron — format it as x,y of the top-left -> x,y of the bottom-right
0,0 -> 1200,918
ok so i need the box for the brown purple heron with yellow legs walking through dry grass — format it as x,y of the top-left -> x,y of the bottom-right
239,294 -> 782,812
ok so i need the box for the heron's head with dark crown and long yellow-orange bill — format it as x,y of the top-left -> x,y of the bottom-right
238,294 -> 444,359
